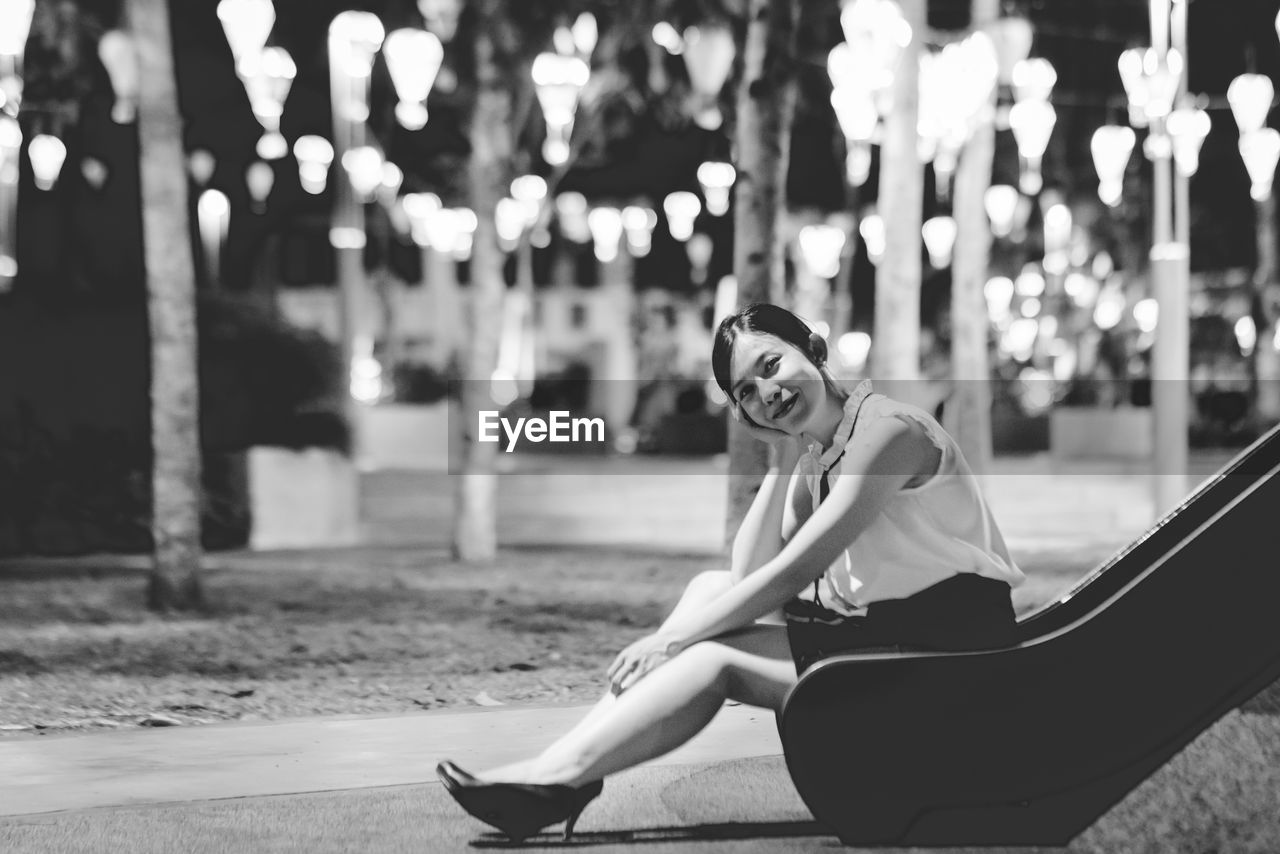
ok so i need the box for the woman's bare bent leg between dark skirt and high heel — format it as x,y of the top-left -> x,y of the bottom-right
485,625 -> 796,785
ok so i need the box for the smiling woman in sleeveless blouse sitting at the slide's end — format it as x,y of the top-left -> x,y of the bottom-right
436,305 -> 1023,841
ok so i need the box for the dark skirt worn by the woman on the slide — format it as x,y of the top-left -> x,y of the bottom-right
783,572 -> 1018,673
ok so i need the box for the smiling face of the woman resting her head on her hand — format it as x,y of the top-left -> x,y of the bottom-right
730,332 -> 827,435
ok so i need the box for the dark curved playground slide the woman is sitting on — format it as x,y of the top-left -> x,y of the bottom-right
778,428 -> 1280,846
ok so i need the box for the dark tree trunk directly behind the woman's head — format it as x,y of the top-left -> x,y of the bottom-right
726,0 -> 800,543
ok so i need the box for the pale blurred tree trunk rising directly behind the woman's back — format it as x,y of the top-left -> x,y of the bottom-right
945,0 -> 1000,474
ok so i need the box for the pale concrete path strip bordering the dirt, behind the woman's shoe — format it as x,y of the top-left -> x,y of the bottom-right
0,705 -> 782,816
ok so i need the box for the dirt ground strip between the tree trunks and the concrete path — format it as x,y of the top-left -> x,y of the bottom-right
0,545 -> 1112,736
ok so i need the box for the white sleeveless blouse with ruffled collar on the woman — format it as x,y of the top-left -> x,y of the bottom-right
796,380 -> 1025,615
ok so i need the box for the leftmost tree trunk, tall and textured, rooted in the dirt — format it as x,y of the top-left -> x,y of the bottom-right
124,0 -> 204,609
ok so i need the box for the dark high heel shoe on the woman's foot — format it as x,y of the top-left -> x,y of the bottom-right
435,759 -> 604,842
